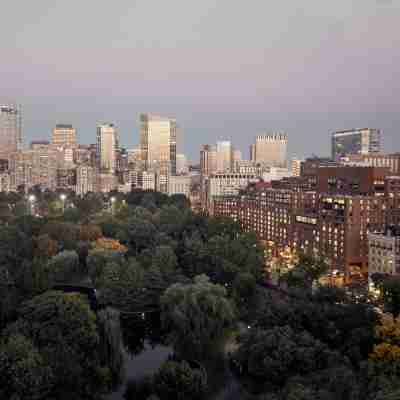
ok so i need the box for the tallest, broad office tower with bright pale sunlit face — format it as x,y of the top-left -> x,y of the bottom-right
140,114 -> 177,175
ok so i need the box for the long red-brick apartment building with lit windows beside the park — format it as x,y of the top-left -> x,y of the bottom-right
213,167 -> 400,273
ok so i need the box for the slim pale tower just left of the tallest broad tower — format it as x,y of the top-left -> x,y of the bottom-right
96,123 -> 117,173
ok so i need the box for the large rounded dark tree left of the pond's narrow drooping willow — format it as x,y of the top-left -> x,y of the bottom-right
8,292 -> 108,398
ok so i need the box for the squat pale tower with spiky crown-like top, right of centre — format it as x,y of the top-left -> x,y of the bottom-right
251,133 -> 288,168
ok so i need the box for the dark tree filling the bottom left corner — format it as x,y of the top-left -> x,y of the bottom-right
0,334 -> 54,400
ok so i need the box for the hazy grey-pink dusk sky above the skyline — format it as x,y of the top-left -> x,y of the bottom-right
0,0 -> 400,161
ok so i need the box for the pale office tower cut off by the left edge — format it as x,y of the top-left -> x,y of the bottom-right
0,104 -> 22,159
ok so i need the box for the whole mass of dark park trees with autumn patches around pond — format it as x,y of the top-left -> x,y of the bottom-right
0,190 -> 400,400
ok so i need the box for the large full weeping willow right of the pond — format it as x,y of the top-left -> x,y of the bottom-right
161,275 -> 234,358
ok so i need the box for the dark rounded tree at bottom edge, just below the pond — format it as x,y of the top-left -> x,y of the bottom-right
154,360 -> 207,400
